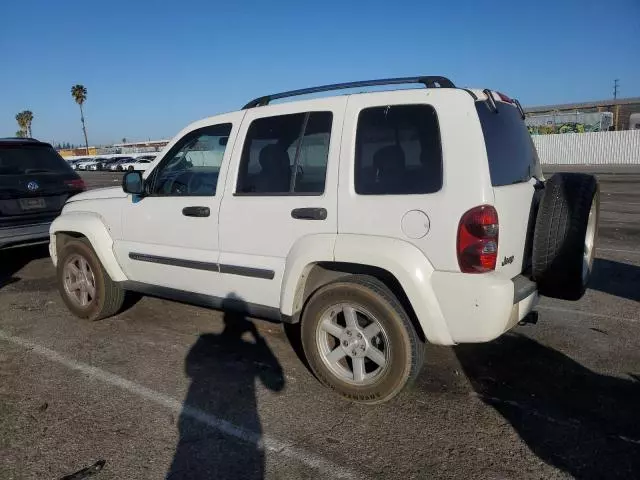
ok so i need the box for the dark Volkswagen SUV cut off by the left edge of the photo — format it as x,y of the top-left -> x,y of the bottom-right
0,138 -> 85,248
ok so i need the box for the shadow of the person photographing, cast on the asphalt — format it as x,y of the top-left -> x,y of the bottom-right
166,296 -> 285,480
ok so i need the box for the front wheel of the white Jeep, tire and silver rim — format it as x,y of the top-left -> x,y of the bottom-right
56,238 -> 125,320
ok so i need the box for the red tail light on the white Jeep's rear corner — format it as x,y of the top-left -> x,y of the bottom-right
457,205 -> 498,273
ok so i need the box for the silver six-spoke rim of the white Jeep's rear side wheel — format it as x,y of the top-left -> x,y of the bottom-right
316,303 -> 390,385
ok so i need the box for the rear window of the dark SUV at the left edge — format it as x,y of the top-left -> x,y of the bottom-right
0,145 -> 73,175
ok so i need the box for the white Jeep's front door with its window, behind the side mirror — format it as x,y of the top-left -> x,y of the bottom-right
114,113 -> 243,296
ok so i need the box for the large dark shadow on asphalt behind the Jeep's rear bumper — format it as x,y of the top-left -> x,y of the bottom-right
454,334 -> 640,479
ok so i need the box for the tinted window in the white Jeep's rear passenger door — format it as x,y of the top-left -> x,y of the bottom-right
236,112 -> 333,195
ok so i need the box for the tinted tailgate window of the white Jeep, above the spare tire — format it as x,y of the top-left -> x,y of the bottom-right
476,102 -> 539,187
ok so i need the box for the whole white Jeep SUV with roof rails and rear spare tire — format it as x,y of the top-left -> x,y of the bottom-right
50,77 -> 599,403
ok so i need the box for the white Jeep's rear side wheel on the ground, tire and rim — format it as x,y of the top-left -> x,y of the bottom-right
301,275 -> 424,404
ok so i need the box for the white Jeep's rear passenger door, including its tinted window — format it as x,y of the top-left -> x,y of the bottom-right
219,98 -> 346,307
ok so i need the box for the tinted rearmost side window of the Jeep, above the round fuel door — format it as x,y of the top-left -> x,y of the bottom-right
355,105 -> 442,195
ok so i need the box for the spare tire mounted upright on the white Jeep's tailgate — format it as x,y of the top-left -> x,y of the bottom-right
532,173 -> 600,300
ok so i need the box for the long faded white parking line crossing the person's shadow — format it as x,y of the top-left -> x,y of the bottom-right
0,330 -> 365,479
